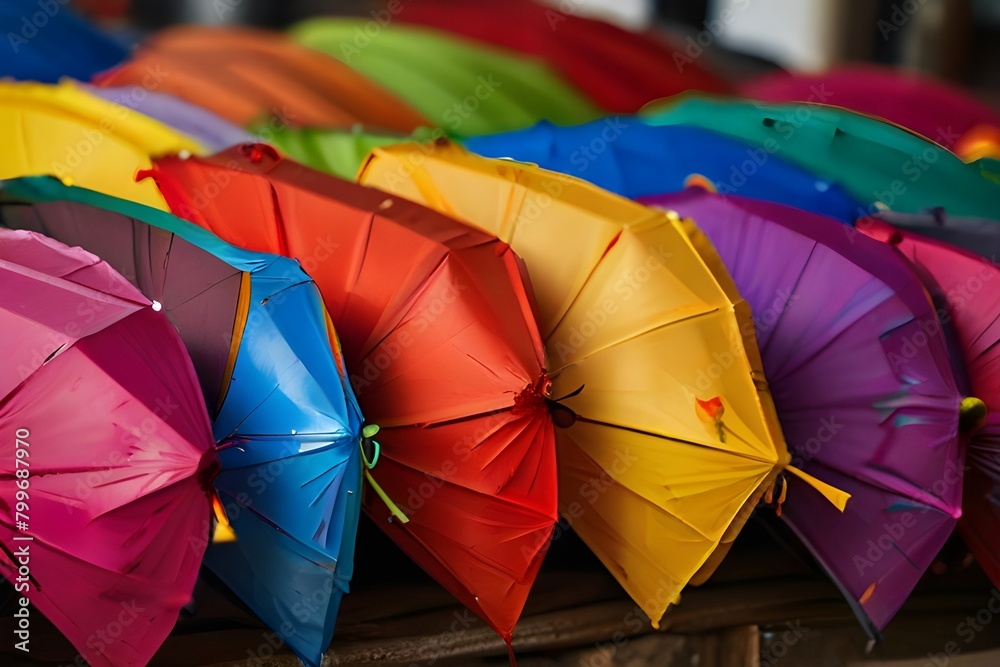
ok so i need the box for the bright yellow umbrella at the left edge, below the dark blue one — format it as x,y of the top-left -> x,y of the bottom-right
0,81 -> 204,211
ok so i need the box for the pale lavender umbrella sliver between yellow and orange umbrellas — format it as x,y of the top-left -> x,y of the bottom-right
80,84 -> 257,151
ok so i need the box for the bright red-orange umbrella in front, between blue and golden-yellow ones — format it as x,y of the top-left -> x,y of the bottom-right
138,145 -> 556,643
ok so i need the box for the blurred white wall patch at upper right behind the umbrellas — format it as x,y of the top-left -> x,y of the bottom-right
706,0 -> 838,70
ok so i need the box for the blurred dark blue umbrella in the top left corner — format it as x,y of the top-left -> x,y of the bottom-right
0,0 -> 128,83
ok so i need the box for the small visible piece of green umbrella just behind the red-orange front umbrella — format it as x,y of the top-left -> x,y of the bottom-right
251,126 -> 434,181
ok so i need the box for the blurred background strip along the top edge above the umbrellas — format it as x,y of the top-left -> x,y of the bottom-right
72,0 -> 1000,107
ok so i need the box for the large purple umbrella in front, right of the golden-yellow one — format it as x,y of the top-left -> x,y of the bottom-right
648,188 -> 964,635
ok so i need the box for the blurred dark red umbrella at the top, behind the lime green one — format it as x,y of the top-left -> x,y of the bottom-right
399,0 -> 729,113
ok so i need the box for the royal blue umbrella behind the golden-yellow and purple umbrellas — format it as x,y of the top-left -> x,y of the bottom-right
463,116 -> 861,222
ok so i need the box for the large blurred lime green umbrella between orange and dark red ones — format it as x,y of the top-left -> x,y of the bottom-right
291,18 -> 600,136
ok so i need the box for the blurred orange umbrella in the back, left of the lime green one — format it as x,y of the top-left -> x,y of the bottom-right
94,25 -> 427,132
